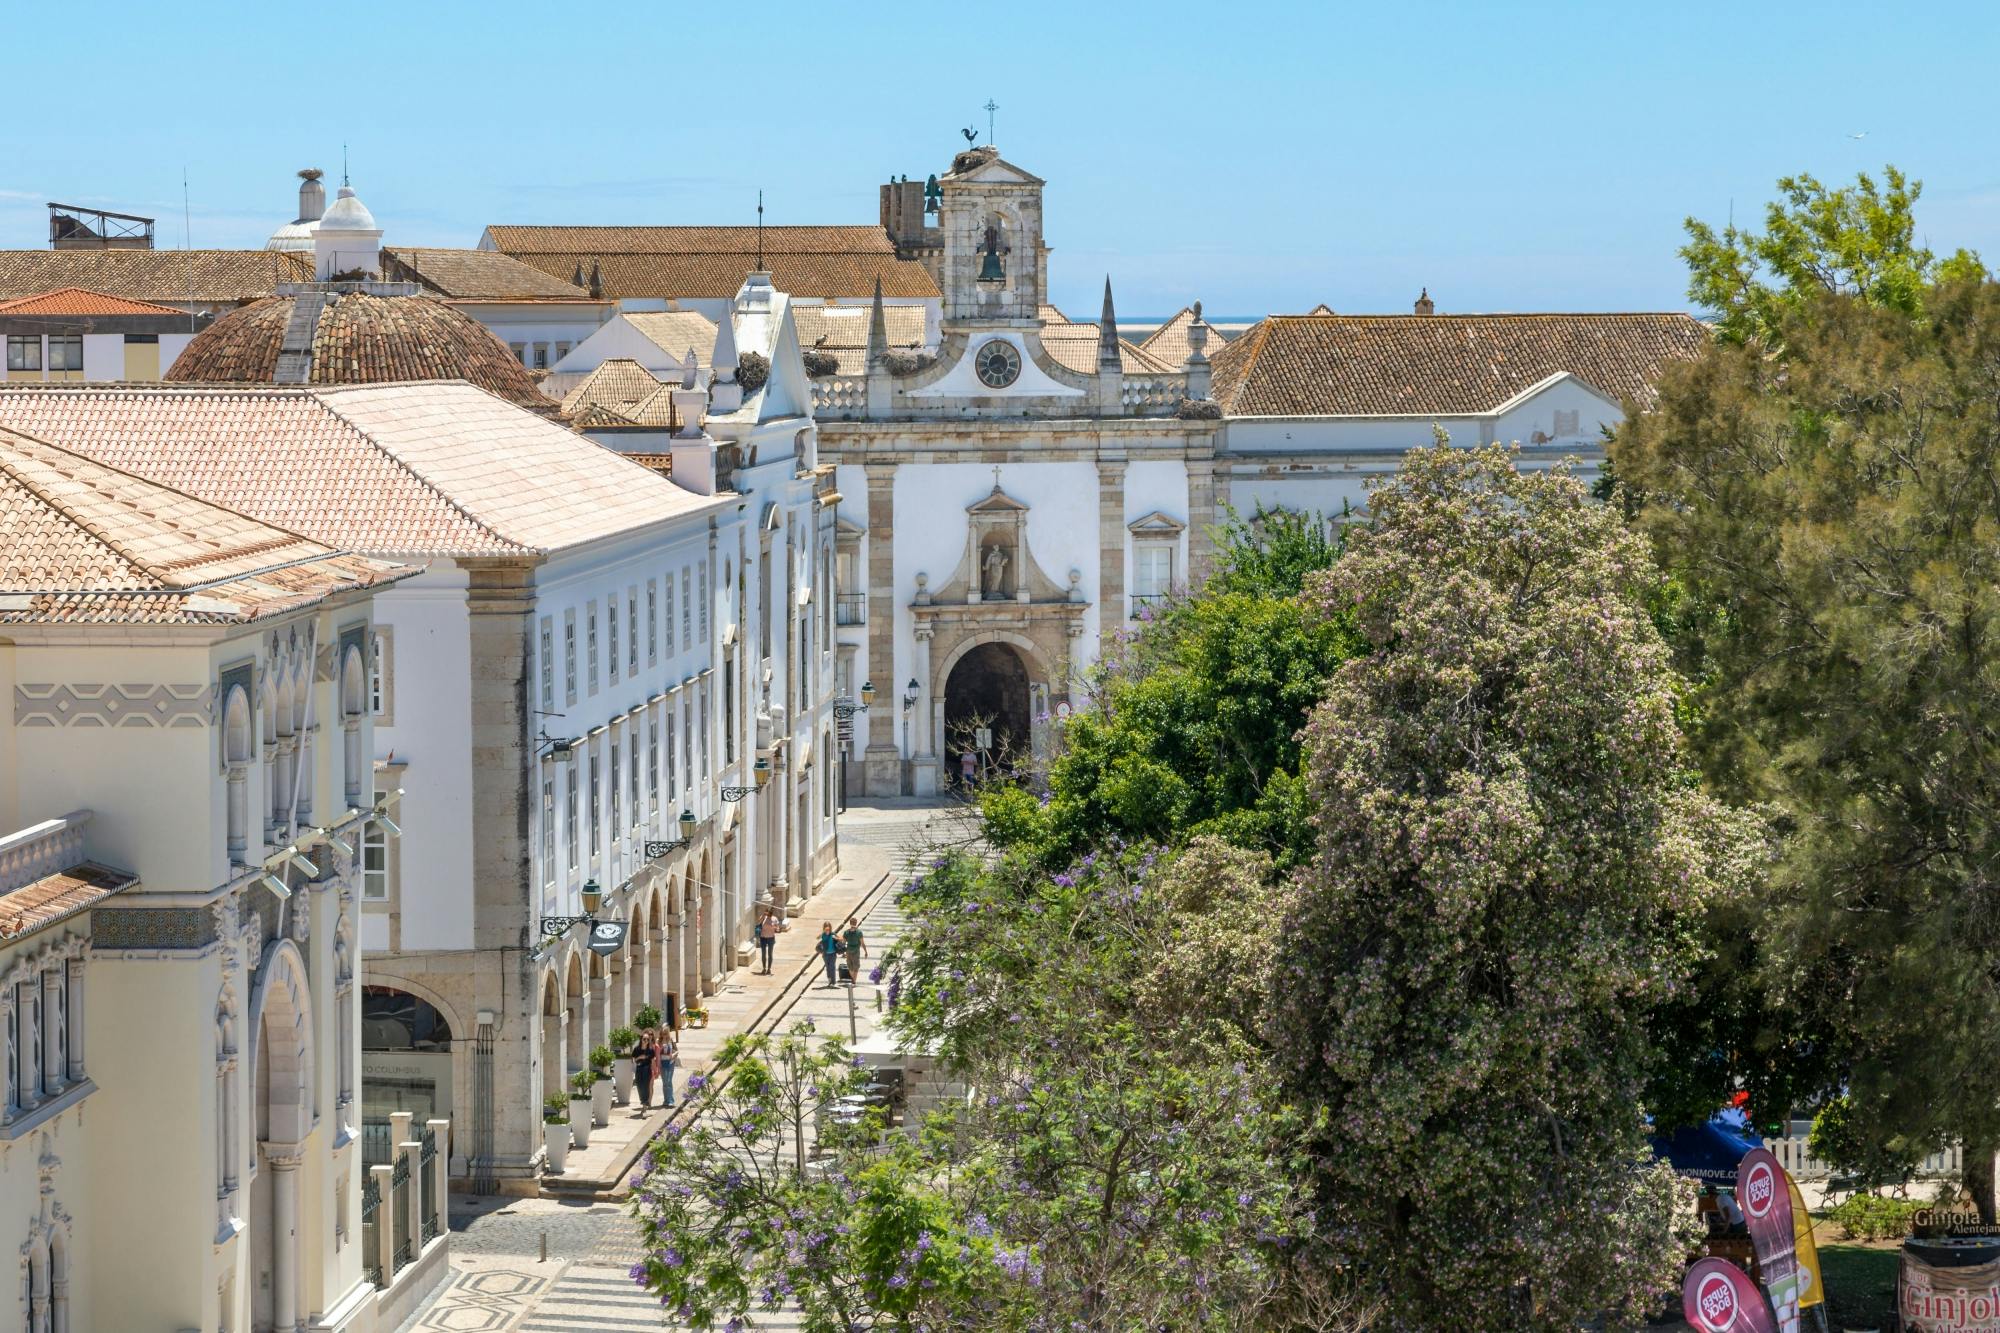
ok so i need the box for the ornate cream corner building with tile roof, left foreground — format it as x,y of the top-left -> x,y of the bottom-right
0,428 -> 448,1333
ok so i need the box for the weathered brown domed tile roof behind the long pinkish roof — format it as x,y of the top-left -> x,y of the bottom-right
162,292 -> 556,412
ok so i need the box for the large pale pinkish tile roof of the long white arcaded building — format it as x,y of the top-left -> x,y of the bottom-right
0,382 -> 712,556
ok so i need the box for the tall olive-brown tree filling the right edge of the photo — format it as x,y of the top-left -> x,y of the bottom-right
1616,278 -> 2000,1211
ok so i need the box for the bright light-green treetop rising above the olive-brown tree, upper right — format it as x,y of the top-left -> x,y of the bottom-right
1680,166 -> 1984,344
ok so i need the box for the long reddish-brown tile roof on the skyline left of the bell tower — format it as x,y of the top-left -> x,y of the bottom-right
500,250 -> 938,300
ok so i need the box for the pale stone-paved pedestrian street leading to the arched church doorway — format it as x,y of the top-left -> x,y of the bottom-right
404,801 -> 966,1333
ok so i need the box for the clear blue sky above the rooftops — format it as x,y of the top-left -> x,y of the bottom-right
0,0 -> 2000,316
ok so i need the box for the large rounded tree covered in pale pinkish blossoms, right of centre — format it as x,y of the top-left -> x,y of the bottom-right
1268,436 -> 1760,1331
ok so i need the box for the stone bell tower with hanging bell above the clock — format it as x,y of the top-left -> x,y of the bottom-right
938,144 -> 1048,328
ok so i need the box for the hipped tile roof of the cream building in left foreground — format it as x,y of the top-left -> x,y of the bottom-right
0,428 -> 416,624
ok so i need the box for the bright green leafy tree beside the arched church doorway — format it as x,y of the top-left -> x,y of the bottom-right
984,510 -> 1356,869
